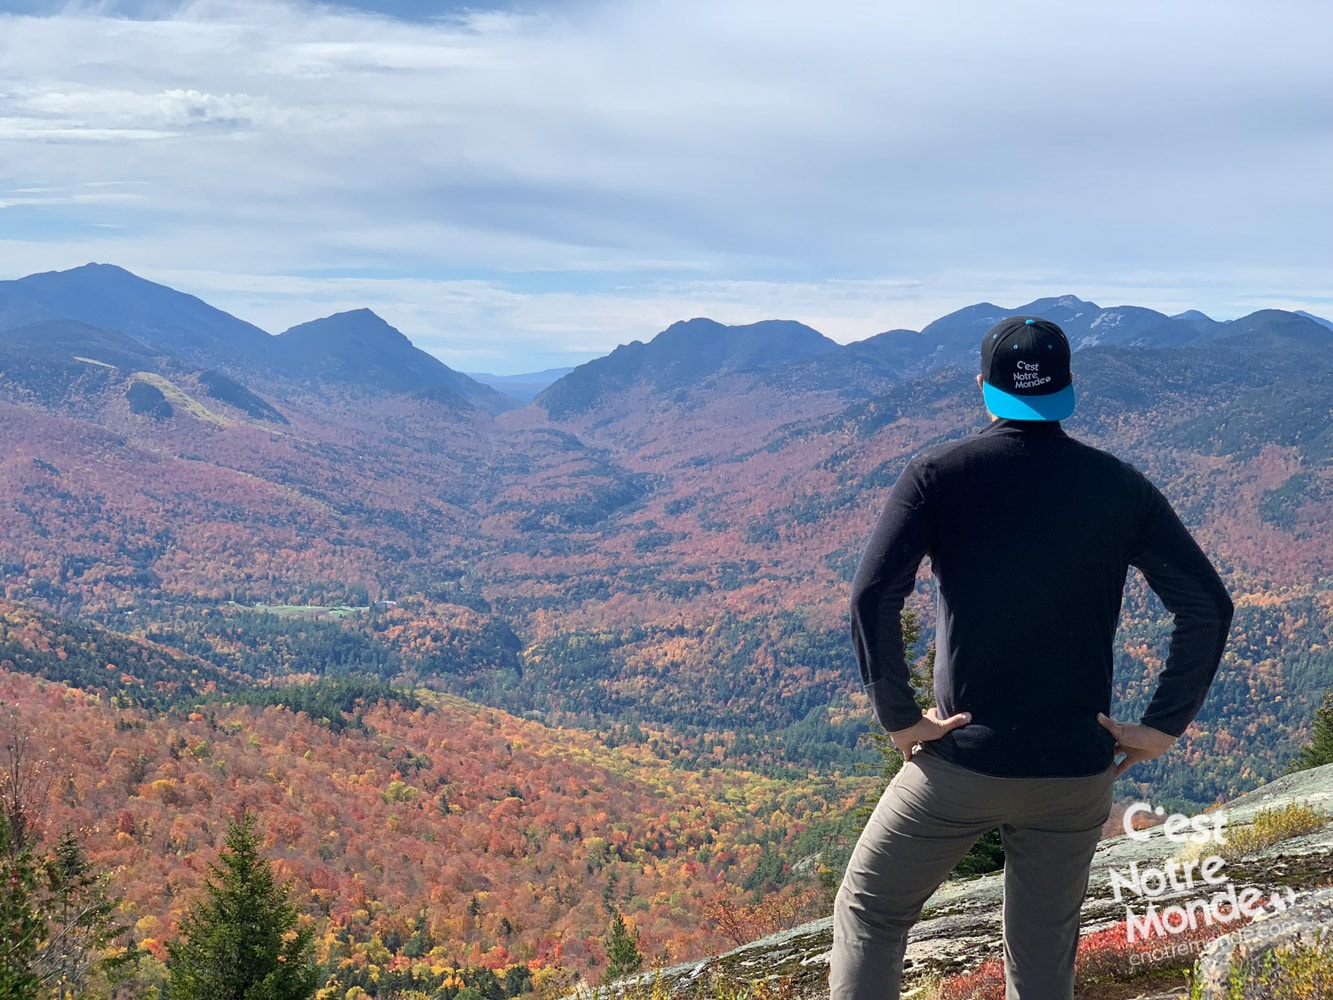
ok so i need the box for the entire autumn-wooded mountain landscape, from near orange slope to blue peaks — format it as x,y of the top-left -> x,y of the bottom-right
0,264 -> 1333,996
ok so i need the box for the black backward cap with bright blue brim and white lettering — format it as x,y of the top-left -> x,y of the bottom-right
981,316 -> 1074,420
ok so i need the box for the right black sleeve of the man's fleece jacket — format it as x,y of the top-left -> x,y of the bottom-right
1130,484 -> 1234,736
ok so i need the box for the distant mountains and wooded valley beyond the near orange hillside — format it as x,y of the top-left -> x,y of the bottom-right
0,264 -> 1333,800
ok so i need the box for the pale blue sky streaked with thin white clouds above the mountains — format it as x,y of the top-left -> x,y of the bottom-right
0,0 -> 1333,373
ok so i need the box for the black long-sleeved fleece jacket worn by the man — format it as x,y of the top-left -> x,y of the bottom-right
852,420 -> 1232,777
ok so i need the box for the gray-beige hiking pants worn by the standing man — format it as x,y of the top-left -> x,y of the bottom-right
829,751 -> 1116,1000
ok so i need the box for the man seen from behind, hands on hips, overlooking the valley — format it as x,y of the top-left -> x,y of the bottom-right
829,316 -> 1232,1000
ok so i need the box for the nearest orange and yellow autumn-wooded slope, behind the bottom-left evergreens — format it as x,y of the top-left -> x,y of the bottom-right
0,664 -> 865,997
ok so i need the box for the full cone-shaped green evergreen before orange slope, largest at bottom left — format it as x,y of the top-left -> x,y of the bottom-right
167,815 -> 319,1000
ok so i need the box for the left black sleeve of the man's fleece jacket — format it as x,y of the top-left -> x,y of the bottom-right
852,461 -> 934,732
